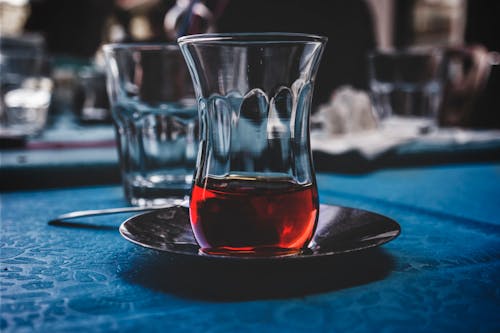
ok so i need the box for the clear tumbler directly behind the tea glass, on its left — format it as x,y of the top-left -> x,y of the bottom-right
103,44 -> 198,206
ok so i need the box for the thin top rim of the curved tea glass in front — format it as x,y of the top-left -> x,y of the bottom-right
177,32 -> 328,45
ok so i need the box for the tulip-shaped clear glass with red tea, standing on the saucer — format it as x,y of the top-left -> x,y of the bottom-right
178,33 -> 326,255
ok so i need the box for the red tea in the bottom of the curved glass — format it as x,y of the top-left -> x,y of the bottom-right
190,176 -> 319,255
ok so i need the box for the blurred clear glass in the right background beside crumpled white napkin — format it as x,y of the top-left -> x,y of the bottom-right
368,48 -> 445,131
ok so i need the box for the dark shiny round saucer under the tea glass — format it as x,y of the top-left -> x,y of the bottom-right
119,204 -> 401,261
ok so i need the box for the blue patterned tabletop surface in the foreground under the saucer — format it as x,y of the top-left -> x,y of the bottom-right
0,163 -> 500,333
